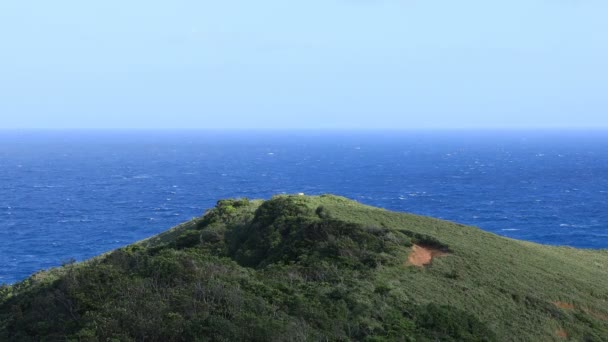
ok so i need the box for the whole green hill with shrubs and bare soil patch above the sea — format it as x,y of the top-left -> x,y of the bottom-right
0,195 -> 608,341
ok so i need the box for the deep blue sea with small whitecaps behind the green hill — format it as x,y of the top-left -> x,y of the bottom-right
0,131 -> 608,283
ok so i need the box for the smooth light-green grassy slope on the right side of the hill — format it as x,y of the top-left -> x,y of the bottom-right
306,199 -> 608,339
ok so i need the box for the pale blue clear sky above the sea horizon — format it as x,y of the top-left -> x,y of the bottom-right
0,0 -> 608,130
